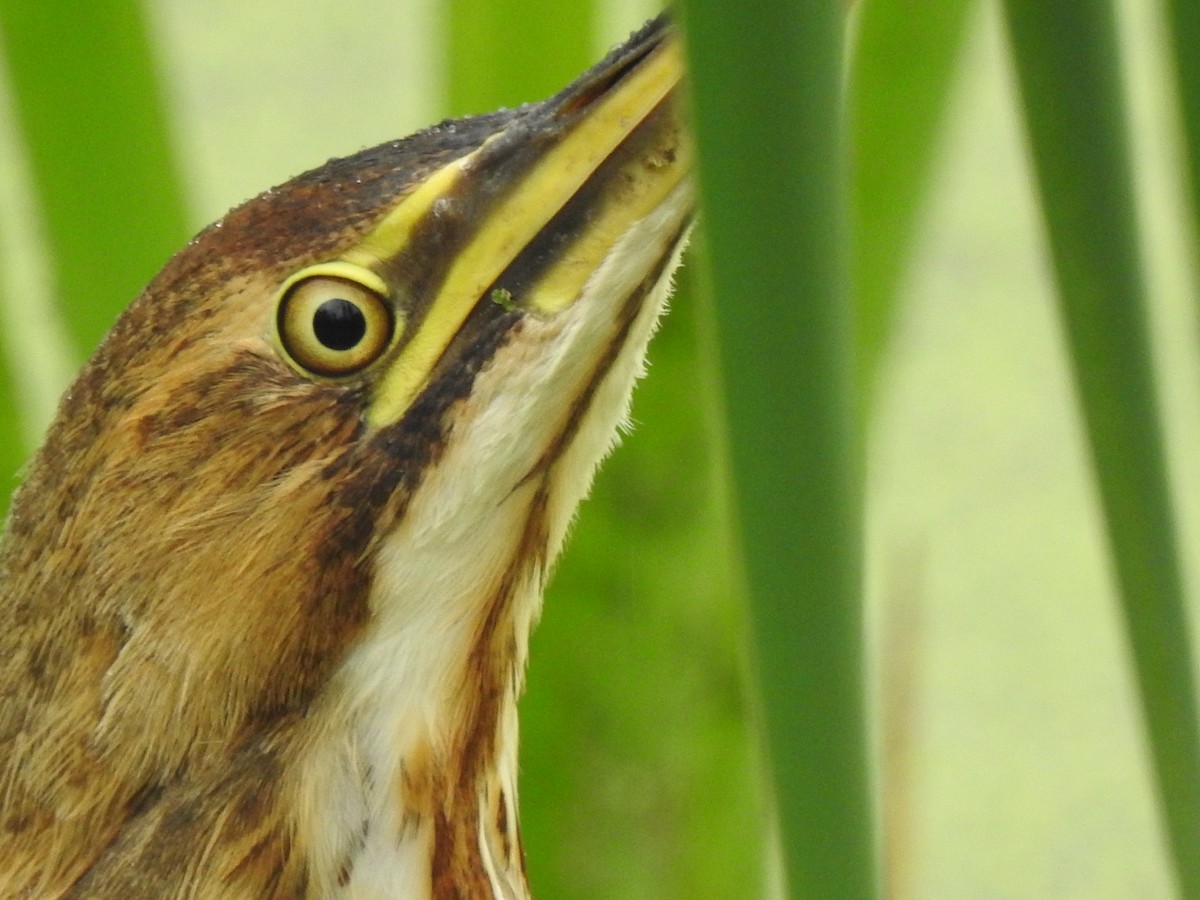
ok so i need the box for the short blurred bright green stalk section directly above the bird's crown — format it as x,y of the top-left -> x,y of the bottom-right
448,0 -> 593,115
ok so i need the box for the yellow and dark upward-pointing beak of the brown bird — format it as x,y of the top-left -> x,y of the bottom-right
314,20 -> 691,428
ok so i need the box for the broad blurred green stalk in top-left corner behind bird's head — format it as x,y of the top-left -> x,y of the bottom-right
0,0 -> 187,352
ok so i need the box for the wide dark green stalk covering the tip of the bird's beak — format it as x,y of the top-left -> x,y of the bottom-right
683,0 -> 876,899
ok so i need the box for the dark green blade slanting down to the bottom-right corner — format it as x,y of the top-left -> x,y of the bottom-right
1004,0 -> 1200,898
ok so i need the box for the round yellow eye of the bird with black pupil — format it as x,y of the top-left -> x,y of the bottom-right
277,275 -> 395,377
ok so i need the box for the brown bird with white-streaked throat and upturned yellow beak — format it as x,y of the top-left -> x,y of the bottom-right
0,18 -> 696,900
